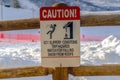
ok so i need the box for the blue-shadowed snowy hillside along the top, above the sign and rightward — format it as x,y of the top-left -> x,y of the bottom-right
30,0 -> 120,11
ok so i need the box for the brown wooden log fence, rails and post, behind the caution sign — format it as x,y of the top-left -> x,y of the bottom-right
0,12 -> 120,80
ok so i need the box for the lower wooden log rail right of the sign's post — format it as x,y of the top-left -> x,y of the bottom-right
70,65 -> 120,76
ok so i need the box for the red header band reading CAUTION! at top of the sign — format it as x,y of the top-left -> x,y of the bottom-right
40,6 -> 80,21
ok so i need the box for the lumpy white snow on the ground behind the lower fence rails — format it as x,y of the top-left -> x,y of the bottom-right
0,35 -> 120,80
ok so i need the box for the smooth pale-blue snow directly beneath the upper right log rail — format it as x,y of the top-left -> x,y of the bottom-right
80,26 -> 120,39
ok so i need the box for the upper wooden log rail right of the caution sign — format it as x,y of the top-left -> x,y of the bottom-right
81,13 -> 120,27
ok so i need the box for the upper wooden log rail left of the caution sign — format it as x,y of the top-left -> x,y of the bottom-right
0,18 -> 40,31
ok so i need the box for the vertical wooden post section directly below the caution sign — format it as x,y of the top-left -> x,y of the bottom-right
52,67 -> 68,80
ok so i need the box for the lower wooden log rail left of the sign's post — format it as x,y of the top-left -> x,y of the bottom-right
0,66 -> 52,79
